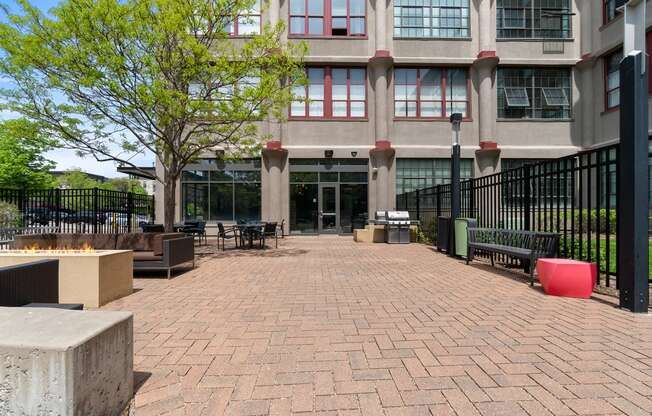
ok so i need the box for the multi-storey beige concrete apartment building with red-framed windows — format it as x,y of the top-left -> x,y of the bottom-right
157,0 -> 652,234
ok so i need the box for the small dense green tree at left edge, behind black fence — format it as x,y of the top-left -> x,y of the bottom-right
0,119 -> 55,189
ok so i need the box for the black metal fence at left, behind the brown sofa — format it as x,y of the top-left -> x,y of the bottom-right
0,188 -> 154,237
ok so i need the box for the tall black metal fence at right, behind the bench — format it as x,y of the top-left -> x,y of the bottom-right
397,141 -> 640,286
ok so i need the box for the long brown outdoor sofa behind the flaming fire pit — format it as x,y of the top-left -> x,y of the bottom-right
15,233 -> 195,278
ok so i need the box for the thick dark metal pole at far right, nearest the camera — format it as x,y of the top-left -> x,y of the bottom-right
616,0 -> 650,313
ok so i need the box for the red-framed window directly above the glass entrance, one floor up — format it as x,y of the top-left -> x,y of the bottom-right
290,67 -> 367,119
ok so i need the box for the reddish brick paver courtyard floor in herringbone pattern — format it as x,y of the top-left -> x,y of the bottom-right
105,237 -> 652,416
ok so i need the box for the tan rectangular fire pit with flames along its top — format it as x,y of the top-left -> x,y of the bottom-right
0,245 -> 133,308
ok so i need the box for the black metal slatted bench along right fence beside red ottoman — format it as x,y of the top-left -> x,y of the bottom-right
466,228 -> 559,286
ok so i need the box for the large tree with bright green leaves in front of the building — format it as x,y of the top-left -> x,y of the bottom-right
0,0 -> 305,230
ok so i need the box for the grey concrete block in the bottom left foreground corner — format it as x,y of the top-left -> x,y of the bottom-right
0,308 -> 133,416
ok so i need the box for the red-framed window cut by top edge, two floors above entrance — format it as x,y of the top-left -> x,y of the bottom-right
290,0 -> 366,36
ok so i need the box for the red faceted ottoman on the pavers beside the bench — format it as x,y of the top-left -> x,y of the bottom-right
537,259 -> 598,299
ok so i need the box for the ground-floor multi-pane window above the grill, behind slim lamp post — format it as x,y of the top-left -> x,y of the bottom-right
396,159 -> 473,195
